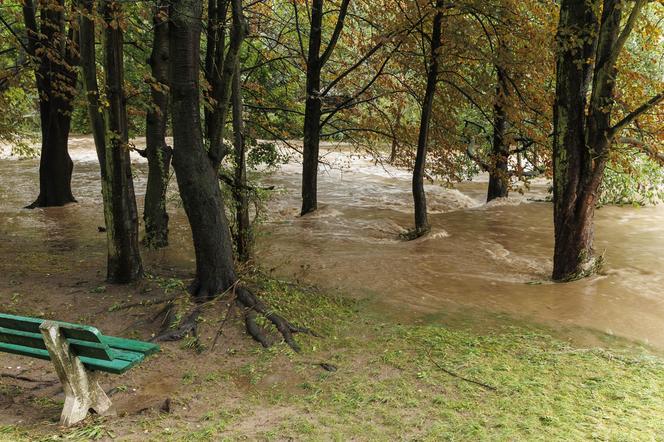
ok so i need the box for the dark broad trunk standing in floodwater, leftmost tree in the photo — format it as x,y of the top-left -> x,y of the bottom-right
23,0 -> 77,208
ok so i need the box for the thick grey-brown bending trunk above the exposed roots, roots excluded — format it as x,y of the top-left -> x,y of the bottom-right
169,0 -> 237,300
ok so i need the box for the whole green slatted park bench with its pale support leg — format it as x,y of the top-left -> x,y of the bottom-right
0,313 -> 159,426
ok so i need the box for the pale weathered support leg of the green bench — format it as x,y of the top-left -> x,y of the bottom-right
39,321 -> 112,426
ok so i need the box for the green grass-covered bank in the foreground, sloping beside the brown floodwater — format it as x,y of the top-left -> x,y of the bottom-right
0,278 -> 664,441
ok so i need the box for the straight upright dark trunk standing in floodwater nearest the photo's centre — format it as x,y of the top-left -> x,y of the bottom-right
300,0 -> 323,215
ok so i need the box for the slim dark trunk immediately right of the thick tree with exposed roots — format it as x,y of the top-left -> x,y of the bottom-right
232,62 -> 251,262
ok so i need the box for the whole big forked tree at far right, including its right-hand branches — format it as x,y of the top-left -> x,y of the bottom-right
552,0 -> 664,281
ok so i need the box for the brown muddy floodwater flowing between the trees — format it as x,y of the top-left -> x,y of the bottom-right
0,138 -> 664,349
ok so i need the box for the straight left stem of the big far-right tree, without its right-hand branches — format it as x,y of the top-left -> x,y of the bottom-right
553,1 -> 597,280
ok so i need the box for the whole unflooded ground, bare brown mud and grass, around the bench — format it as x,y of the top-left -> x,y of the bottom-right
0,233 -> 664,441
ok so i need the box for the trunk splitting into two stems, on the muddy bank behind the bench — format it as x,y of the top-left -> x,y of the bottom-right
80,0 -> 143,283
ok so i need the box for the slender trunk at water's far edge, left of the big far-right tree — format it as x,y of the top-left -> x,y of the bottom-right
486,66 -> 510,202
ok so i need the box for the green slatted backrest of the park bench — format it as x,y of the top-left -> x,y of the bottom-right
0,313 -> 115,361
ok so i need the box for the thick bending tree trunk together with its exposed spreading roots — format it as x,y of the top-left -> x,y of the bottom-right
166,0 -> 310,351
